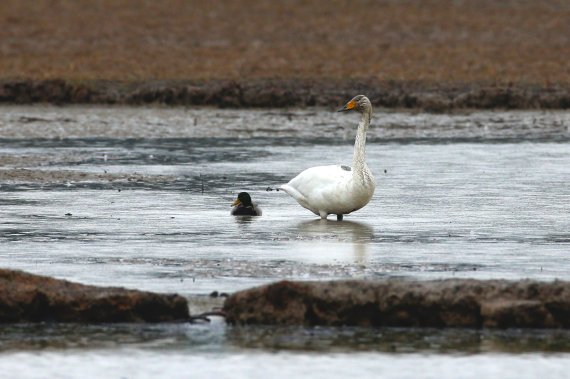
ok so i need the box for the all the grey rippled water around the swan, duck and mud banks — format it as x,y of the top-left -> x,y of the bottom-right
0,107 -> 570,378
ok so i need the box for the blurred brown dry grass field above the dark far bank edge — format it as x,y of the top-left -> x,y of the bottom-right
0,0 -> 570,85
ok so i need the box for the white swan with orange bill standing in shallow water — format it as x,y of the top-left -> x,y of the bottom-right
280,95 -> 376,221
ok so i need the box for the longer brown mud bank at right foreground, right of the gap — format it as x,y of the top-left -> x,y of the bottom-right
224,279 -> 570,328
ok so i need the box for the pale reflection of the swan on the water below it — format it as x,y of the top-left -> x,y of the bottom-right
288,219 -> 374,265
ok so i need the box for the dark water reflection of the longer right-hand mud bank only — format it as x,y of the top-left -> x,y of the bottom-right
226,326 -> 570,354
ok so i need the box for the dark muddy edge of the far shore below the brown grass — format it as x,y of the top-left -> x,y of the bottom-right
0,79 -> 570,112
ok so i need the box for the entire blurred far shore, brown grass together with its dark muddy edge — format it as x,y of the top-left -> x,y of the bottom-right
0,0 -> 570,111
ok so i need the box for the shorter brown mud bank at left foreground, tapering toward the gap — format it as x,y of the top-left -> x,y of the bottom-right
0,269 -> 190,323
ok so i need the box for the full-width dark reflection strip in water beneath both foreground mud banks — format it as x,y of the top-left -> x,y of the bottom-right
0,320 -> 570,354
